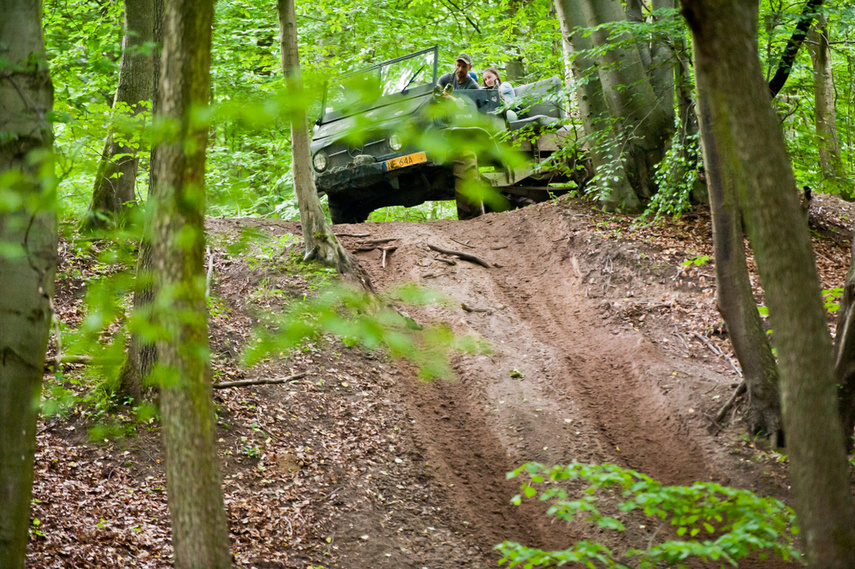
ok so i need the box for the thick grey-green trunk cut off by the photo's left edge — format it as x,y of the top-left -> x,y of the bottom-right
0,0 -> 57,569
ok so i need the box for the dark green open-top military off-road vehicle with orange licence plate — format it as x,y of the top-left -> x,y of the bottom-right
311,47 -> 586,223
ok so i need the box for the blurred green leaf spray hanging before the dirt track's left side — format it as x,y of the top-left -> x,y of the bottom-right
243,284 -> 486,378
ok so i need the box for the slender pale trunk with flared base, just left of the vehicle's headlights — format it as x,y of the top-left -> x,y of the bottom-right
276,0 -> 353,273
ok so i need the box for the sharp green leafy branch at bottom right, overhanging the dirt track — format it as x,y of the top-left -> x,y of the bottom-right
496,462 -> 799,569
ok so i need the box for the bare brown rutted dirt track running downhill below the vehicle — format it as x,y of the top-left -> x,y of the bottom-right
338,205 -> 744,565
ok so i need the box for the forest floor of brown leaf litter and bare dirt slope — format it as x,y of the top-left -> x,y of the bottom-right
28,196 -> 855,569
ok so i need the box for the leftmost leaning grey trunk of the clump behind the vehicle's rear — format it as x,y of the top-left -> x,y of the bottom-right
555,0 -> 641,211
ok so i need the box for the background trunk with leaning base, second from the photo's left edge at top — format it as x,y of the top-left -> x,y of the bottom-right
81,0 -> 154,230
